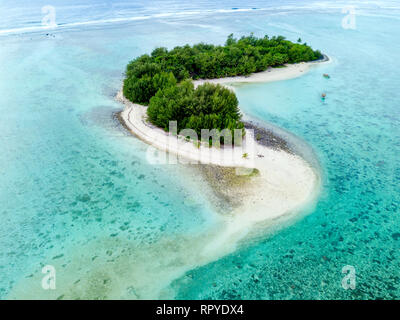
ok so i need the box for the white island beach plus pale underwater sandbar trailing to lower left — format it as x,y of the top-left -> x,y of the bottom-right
8,58 -> 328,299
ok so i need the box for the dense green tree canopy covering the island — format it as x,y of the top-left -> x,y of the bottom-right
123,35 -> 322,141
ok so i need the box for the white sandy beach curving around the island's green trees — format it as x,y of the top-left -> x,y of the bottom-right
116,60 -> 330,252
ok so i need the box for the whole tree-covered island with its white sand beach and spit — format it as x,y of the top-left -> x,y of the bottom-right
116,35 -> 329,249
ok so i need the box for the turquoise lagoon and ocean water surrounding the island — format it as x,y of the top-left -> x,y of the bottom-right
0,0 -> 400,299
